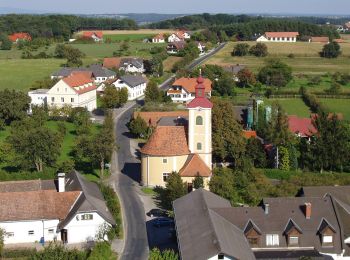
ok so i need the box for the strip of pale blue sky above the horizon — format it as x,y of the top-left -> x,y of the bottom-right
0,0 -> 350,15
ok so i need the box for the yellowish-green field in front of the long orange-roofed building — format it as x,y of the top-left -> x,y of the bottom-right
206,42 -> 350,74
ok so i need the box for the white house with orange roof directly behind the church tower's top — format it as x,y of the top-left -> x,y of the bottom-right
167,78 -> 212,103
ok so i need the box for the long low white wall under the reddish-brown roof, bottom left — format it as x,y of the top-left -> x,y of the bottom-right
0,219 -> 61,244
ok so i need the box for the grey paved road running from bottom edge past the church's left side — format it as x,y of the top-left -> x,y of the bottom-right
112,102 -> 148,260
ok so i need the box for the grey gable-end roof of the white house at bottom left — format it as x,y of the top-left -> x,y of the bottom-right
59,171 -> 115,228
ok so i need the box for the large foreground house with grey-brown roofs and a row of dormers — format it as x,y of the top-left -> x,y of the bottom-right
173,188 -> 350,260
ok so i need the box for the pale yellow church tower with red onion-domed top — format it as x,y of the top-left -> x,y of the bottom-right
187,76 -> 213,169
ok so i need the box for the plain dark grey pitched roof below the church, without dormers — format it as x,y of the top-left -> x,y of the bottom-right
173,189 -> 255,260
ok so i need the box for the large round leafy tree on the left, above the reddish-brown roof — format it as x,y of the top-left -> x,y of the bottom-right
8,119 -> 62,172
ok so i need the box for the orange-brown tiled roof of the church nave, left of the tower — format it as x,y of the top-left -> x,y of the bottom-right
141,126 -> 190,156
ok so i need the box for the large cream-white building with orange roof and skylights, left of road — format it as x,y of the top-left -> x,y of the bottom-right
47,72 -> 97,111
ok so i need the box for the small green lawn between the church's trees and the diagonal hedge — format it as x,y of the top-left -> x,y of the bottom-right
264,98 -> 311,117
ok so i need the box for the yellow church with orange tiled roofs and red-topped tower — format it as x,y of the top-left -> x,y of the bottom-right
141,76 -> 213,191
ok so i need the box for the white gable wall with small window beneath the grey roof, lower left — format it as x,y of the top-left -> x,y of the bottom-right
64,212 -> 109,243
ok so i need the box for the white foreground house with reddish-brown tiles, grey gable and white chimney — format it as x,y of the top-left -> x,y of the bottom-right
0,171 -> 115,245
